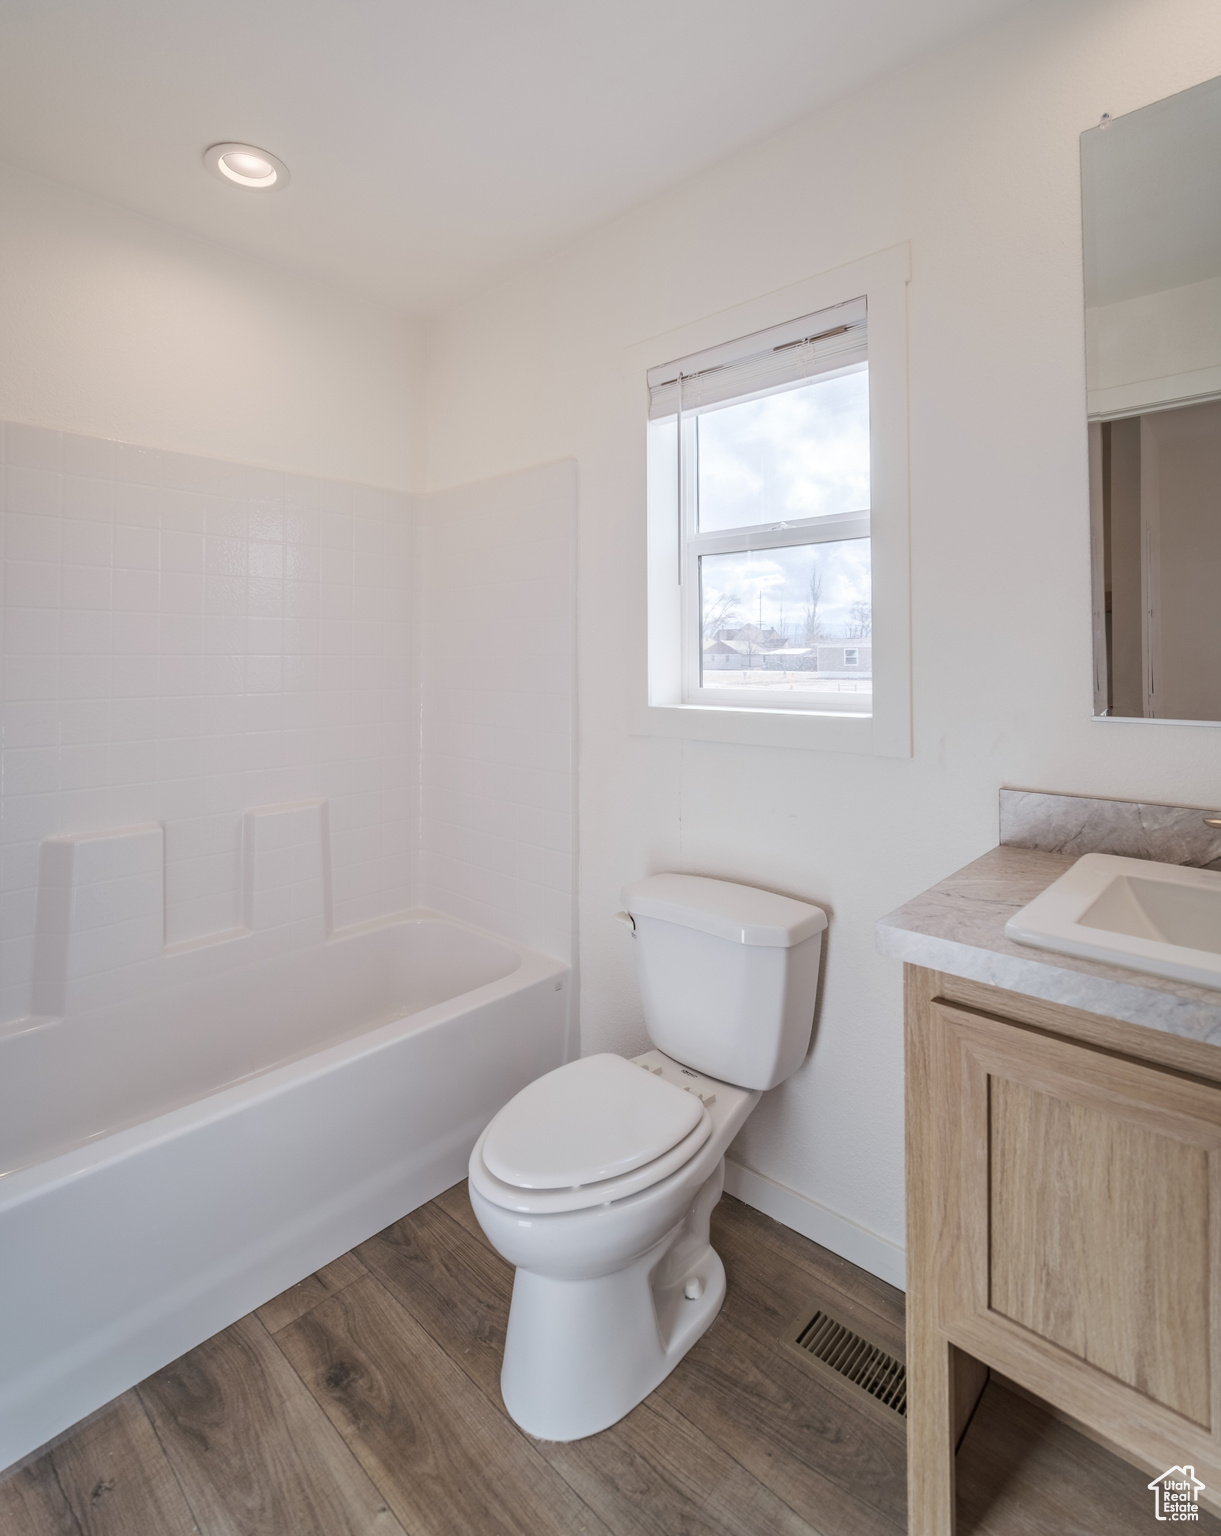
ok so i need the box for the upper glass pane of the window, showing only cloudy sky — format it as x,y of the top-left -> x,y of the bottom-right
697,362 -> 869,533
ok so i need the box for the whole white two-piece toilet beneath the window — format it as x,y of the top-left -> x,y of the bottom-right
470,874 -> 826,1441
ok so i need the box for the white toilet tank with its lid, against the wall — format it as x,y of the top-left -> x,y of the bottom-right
624,874 -> 826,1087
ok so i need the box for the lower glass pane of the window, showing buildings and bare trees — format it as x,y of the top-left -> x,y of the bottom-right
699,539 -> 874,694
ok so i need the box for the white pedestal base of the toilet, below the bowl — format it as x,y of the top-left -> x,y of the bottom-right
501,1160 -> 725,1441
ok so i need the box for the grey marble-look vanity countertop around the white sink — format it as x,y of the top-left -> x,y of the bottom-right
877,846 -> 1221,1044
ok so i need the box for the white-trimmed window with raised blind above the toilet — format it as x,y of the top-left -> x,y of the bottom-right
638,246 -> 911,757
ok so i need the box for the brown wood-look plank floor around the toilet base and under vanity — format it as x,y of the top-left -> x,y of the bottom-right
0,1184 -> 1204,1536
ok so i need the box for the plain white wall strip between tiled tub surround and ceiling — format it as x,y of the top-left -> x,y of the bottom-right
0,166 -> 424,490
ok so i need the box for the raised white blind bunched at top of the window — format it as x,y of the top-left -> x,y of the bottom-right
648,298 -> 868,419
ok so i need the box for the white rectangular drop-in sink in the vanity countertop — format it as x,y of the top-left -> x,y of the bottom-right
1004,854 -> 1221,988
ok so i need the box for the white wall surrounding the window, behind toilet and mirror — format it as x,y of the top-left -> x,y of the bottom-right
429,0 -> 1221,1273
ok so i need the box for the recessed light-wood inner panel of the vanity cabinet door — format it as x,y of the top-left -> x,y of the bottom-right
989,1072 -> 1212,1427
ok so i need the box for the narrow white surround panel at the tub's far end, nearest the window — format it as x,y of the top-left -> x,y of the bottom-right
416,461 -> 576,960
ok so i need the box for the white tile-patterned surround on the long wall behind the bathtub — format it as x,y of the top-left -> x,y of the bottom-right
0,424 -> 418,1023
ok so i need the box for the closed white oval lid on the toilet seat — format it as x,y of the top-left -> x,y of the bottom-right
482,1055 -> 705,1189
